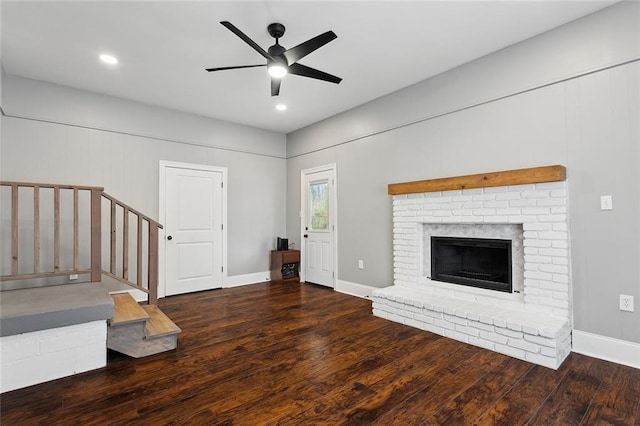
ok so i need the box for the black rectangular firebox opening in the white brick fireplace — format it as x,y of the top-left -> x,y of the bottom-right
431,237 -> 512,293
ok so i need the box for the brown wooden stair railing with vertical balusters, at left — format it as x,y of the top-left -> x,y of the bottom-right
0,181 -> 162,305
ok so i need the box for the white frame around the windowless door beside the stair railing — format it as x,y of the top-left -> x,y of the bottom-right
158,160 -> 227,298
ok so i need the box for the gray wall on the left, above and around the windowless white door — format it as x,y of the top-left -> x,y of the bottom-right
0,75 -> 286,276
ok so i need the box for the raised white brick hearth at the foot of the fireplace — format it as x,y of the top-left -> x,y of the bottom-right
372,286 -> 571,370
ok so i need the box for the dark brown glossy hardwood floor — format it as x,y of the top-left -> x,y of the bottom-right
0,283 -> 640,425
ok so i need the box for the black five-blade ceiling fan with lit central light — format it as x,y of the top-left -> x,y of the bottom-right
206,21 -> 342,96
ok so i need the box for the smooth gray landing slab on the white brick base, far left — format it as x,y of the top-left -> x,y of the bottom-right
0,283 -> 113,336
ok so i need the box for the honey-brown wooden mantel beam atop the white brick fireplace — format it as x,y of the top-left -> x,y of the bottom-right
388,165 -> 567,195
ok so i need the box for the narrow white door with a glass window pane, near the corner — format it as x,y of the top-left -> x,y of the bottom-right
302,168 -> 335,287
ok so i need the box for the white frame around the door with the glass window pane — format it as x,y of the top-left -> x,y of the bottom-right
298,163 -> 338,290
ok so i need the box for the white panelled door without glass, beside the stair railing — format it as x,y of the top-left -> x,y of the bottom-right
164,167 -> 223,296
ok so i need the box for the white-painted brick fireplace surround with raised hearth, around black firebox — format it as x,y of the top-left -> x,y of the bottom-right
372,166 -> 571,369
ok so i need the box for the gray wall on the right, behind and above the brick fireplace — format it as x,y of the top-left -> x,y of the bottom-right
287,3 -> 640,343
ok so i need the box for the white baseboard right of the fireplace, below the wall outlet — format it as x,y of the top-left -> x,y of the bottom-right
572,330 -> 640,368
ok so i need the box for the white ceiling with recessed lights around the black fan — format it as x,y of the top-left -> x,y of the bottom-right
1,0 -> 614,133
